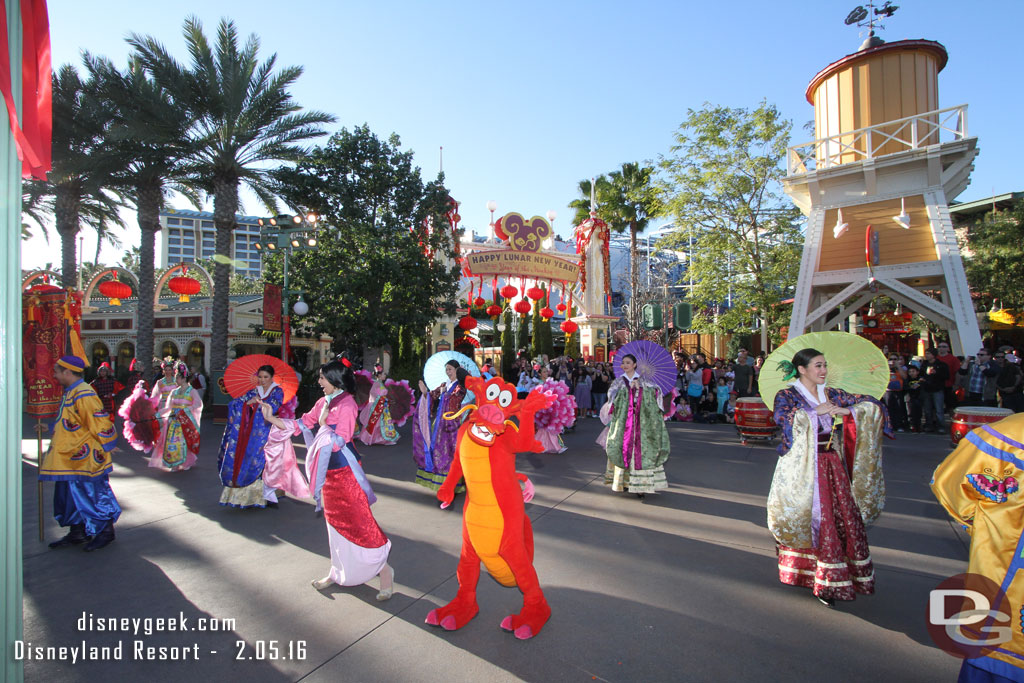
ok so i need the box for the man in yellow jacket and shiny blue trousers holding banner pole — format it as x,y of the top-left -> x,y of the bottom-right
39,355 -> 121,552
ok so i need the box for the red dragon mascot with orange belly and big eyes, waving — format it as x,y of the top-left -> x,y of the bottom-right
426,370 -> 553,640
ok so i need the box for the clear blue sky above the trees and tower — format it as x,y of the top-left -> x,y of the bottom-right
23,0 -> 1024,266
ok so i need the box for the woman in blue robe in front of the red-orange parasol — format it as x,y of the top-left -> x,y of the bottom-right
217,358 -> 285,508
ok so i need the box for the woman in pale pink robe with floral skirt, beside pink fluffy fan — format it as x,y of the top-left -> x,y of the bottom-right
150,360 -> 203,472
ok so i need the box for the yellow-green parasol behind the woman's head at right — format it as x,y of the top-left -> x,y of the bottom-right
758,332 -> 889,408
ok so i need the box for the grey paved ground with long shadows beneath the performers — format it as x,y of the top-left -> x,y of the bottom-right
23,411 -> 967,683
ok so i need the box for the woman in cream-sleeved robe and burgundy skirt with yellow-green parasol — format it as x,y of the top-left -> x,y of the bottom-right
761,332 -> 893,606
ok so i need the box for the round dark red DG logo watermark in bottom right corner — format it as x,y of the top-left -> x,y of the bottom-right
927,573 -> 1019,659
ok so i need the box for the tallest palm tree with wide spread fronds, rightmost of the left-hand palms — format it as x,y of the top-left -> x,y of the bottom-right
128,16 -> 335,372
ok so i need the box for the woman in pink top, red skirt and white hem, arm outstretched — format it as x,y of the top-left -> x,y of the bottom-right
261,358 -> 394,600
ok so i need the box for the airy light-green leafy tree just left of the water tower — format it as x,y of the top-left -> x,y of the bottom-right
659,101 -> 803,342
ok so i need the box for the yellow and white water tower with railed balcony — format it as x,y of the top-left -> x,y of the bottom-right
783,22 -> 981,354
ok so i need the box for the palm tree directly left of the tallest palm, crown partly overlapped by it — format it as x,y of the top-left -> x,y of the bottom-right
85,54 -> 201,372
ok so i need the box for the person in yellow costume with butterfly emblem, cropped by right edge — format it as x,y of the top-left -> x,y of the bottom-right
932,414 -> 1024,683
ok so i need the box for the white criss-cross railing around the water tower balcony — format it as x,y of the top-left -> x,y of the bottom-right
786,104 -> 968,175
